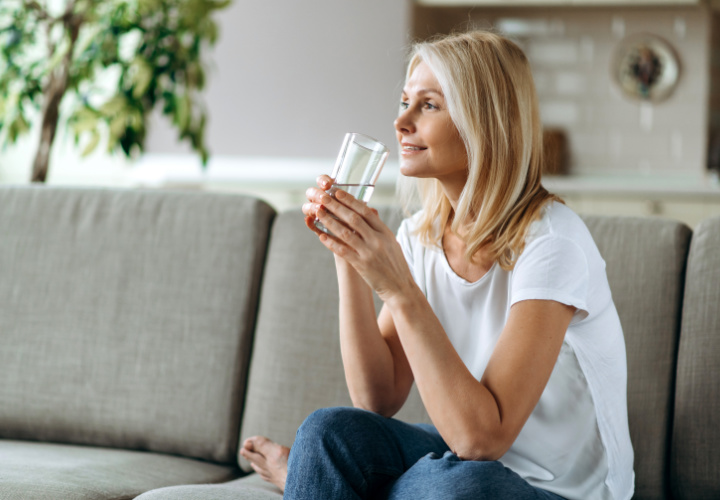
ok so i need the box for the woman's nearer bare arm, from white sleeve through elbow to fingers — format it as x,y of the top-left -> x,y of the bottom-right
318,188 -> 574,459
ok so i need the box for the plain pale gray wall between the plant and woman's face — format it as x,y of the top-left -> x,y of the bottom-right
148,0 -> 410,157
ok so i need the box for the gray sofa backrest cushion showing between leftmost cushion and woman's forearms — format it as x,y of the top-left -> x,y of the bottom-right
238,208 -> 429,471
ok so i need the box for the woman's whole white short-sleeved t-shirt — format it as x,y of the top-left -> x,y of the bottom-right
397,203 -> 634,500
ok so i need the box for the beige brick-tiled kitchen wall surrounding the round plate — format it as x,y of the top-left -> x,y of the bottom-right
414,6 -> 717,177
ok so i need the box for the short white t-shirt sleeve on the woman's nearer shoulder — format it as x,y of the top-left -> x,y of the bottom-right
510,235 -> 590,323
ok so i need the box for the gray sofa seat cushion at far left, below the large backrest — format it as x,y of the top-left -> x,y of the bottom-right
0,440 -> 238,500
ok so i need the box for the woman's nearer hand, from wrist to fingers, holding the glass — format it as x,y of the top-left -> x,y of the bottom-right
303,184 -> 415,302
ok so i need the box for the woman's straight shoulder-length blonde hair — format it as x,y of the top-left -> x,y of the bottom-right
399,31 -> 562,270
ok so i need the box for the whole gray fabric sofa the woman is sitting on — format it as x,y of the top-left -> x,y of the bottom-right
0,187 -> 720,500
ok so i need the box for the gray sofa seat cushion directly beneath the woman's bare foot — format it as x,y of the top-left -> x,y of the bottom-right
137,474 -> 282,500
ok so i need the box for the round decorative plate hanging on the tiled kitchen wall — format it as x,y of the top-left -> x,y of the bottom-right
612,34 -> 680,102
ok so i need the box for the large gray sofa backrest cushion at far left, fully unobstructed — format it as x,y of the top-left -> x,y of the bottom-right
0,187 -> 274,463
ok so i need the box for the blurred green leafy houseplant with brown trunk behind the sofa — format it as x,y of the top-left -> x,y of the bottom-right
0,0 -> 230,182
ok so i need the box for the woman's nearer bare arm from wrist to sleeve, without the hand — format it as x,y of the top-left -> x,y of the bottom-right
388,295 -> 574,460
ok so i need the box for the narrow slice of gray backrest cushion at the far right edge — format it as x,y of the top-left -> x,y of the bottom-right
671,217 -> 720,500
